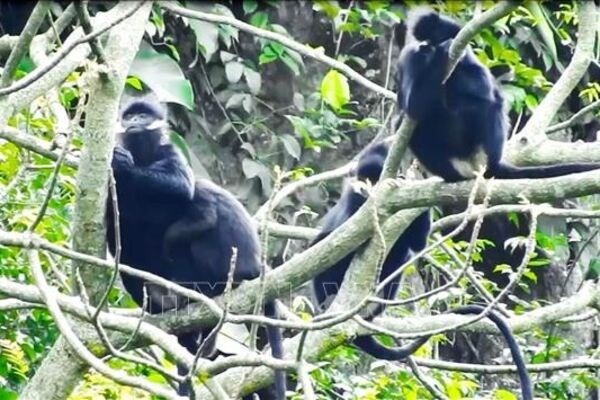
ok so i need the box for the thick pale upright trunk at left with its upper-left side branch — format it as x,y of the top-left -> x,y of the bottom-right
19,2 -> 152,399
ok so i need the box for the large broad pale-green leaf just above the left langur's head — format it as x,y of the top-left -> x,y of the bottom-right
129,42 -> 194,110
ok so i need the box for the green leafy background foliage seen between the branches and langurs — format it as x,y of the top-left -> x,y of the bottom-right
0,0 -> 600,400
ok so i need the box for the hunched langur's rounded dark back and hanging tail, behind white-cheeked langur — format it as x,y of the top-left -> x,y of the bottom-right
163,179 -> 286,400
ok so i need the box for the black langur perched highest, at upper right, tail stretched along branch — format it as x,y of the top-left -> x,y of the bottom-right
396,8 -> 600,182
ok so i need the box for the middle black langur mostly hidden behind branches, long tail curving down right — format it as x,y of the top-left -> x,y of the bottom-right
313,143 -> 533,400
